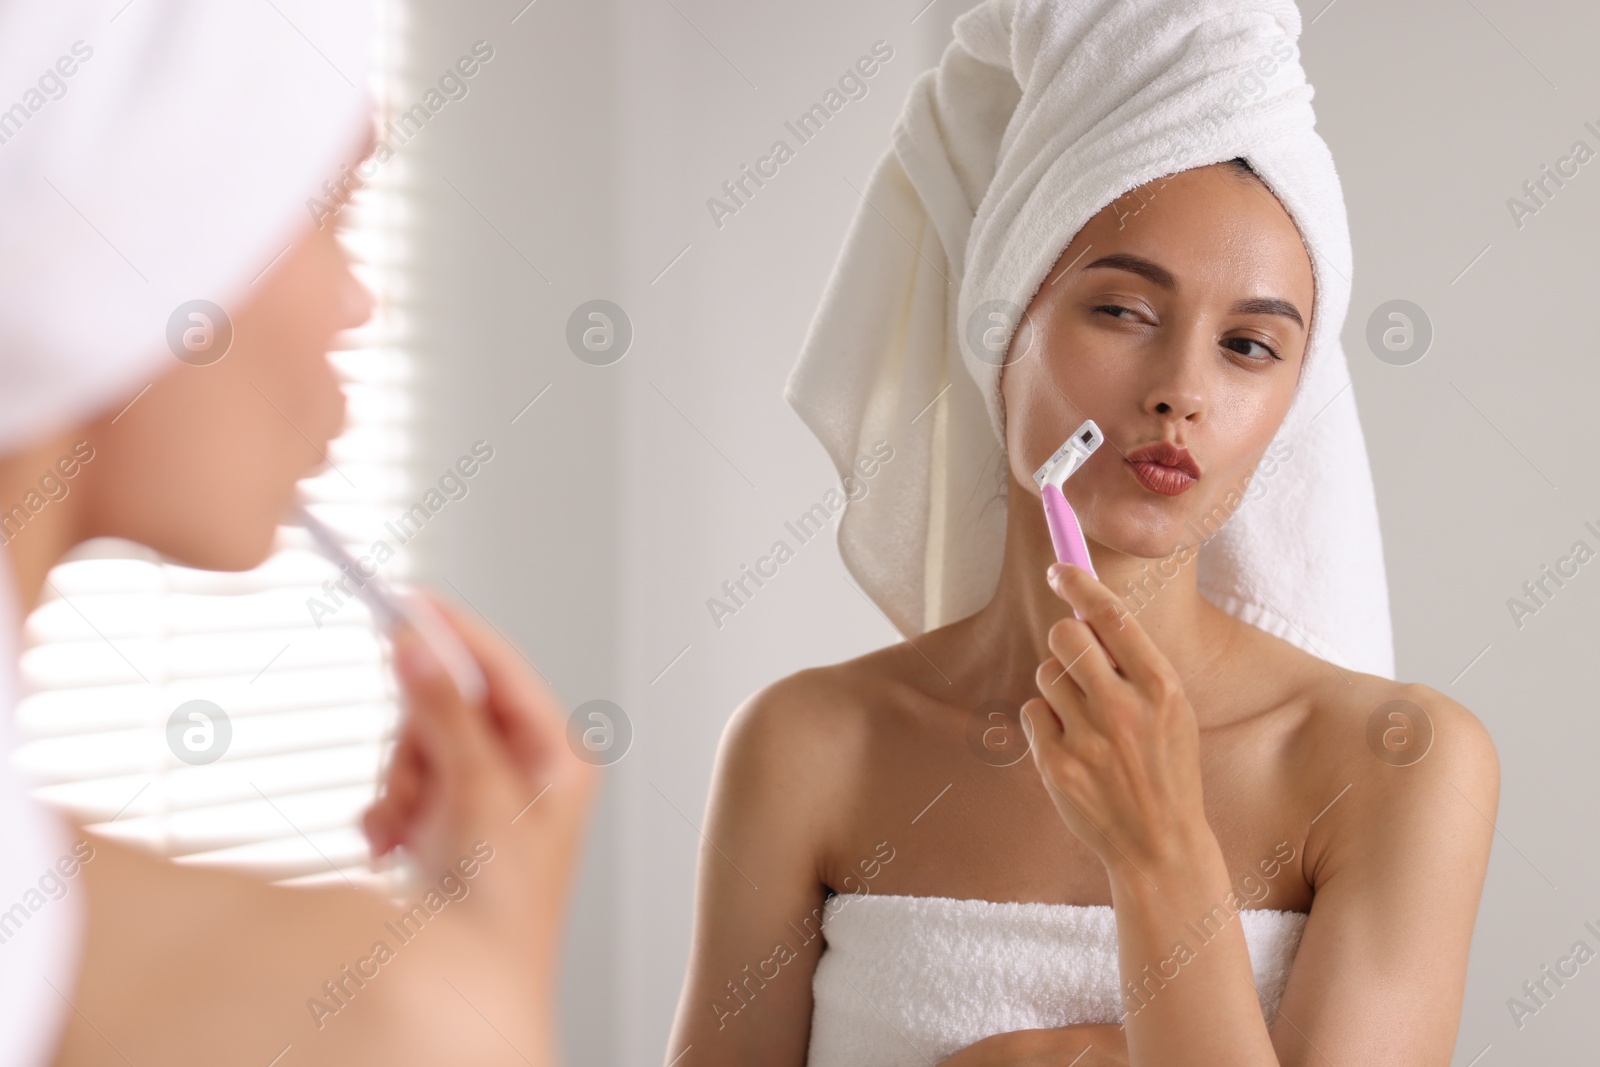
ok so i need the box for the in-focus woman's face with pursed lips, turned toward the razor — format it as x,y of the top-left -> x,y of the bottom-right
1000,163 -> 1314,558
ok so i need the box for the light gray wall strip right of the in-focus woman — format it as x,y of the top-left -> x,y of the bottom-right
1302,2 -> 1600,1067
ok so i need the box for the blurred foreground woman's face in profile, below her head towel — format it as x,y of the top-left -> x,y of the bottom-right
82,204 -> 373,571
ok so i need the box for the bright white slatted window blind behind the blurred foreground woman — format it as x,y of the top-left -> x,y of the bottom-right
16,0 -> 413,888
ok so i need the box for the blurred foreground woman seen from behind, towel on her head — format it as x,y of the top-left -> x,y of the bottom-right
0,0 -> 594,1065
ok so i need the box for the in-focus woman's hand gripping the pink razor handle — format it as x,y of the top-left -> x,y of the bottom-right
1022,563 -> 1211,877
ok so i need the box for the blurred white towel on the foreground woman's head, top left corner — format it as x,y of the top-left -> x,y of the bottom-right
0,0 -> 373,454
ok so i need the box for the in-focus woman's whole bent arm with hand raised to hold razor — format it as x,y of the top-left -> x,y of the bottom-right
1024,568 -> 1499,1067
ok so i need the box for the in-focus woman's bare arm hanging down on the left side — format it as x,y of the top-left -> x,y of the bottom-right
664,672 -> 840,1067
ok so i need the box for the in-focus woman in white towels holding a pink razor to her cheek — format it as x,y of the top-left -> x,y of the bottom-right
666,0 -> 1499,1067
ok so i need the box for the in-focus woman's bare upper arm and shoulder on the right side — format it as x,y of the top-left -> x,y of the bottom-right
1272,685 -> 1499,1067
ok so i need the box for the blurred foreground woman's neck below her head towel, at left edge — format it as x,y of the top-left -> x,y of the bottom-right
0,432 -> 78,616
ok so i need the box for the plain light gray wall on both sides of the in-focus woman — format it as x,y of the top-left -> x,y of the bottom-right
408,0 -> 1600,1067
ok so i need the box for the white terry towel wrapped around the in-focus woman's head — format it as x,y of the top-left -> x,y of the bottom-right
786,0 -> 1394,677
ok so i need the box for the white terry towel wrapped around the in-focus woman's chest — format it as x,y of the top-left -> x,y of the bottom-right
806,893 -> 1306,1067
